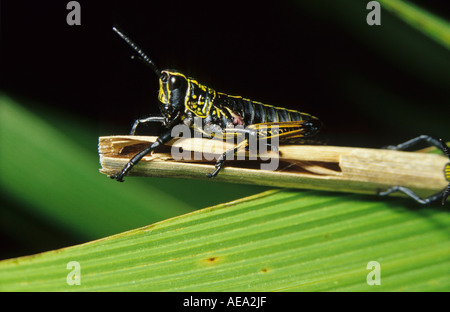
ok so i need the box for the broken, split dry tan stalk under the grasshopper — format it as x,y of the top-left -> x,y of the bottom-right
99,136 -> 448,196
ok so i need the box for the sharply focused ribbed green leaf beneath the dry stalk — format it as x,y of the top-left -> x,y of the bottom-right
0,190 -> 450,291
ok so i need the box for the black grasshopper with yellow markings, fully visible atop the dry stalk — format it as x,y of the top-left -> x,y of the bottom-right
111,27 -> 322,182
